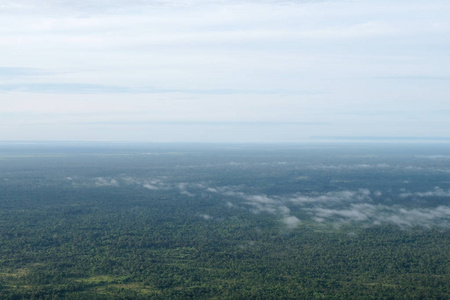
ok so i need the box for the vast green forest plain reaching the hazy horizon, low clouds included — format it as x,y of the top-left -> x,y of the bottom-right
0,144 -> 450,299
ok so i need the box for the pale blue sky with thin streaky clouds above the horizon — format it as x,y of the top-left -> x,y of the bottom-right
0,0 -> 450,143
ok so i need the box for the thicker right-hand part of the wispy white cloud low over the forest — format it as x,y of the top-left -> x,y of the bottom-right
205,186 -> 450,229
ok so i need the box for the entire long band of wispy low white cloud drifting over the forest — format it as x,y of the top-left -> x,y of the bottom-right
66,176 -> 450,230
